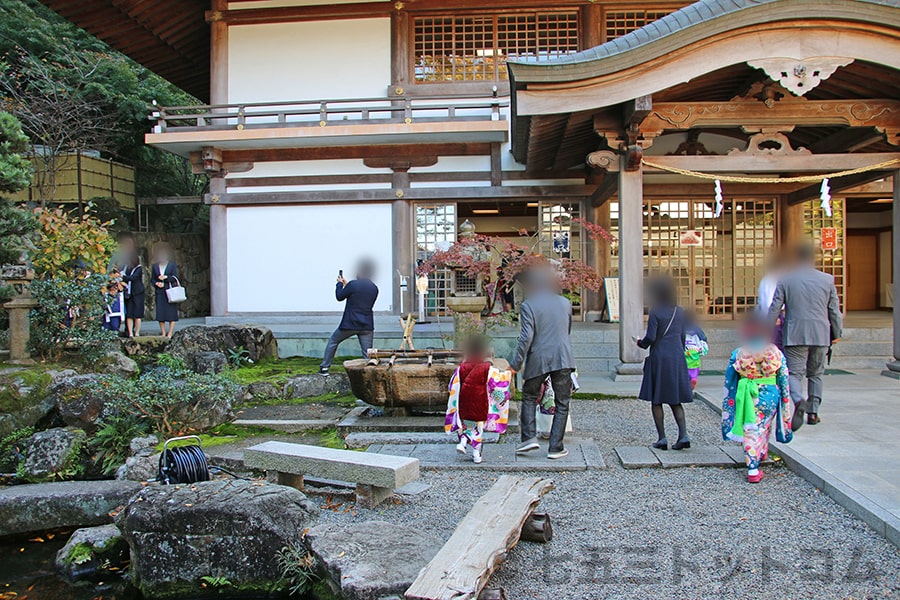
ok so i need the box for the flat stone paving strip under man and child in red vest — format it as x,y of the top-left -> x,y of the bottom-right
367,437 -> 606,471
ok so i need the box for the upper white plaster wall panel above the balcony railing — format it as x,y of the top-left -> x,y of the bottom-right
228,18 -> 391,103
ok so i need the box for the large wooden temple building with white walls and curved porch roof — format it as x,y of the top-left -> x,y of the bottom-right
35,0 -> 900,372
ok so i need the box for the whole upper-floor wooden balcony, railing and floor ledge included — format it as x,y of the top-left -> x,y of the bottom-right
146,96 -> 509,156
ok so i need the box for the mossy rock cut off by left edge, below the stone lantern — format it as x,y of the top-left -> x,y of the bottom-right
0,367 -> 56,438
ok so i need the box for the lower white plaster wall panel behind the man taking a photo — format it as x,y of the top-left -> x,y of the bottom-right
227,204 -> 393,312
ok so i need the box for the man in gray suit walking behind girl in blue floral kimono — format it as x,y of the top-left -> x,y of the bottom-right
769,244 -> 843,430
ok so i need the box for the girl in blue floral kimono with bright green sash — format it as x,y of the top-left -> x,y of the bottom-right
722,314 -> 793,483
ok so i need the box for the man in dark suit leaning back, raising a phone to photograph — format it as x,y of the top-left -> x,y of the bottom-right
319,261 -> 378,375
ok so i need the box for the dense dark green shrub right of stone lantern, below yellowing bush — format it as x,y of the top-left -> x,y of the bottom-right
30,274 -> 118,364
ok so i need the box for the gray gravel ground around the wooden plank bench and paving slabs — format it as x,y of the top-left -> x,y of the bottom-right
322,400 -> 900,600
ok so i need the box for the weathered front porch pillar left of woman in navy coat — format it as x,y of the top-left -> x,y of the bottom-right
616,155 -> 644,375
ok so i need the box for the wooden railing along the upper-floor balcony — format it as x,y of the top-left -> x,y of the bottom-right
149,92 -> 509,133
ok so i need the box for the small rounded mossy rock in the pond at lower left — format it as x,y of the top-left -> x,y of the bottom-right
56,524 -> 128,583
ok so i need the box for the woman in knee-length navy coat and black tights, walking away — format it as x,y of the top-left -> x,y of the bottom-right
636,277 -> 694,450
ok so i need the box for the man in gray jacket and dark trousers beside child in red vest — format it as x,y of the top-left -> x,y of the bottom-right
510,269 -> 575,459
